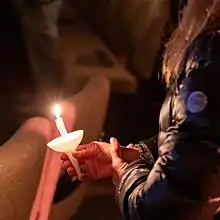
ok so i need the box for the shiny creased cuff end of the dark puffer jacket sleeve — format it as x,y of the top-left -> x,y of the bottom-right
115,159 -> 150,217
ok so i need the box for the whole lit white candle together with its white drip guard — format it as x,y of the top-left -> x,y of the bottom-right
47,104 -> 84,175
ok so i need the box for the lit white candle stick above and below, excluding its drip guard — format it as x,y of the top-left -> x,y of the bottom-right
53,104 -> 81,176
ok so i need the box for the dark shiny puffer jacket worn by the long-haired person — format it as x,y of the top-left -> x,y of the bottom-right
116,30 -> 220,220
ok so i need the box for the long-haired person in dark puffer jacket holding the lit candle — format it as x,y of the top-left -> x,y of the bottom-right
61,0 -> 220,220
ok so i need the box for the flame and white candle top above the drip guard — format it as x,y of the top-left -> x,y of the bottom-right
53,104 -> 67,136
